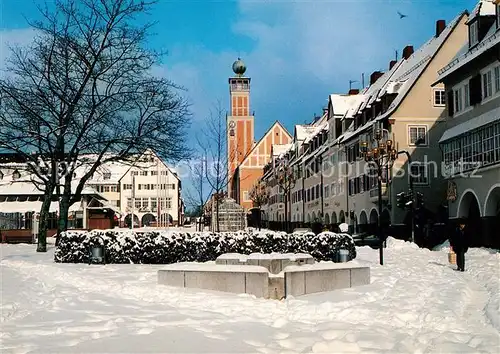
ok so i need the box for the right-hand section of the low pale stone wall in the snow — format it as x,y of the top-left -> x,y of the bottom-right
284,262 -> 370,296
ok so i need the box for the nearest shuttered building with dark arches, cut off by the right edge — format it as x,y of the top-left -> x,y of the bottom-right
436,0 -> 500,248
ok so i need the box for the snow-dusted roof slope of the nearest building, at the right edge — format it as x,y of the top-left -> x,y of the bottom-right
434,24 -> 500,84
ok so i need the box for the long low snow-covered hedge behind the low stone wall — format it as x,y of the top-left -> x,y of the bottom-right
54,230 -> 356,264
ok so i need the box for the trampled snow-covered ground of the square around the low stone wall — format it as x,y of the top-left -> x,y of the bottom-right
0,239 -> 500,354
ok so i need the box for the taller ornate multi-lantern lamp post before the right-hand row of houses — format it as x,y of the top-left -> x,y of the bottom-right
360,122 -> 398,265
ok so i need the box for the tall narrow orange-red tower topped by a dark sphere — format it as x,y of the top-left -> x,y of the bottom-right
227,58 -> 254,191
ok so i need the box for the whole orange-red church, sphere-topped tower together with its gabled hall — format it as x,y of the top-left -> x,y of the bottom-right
227,58 -> 292,211
